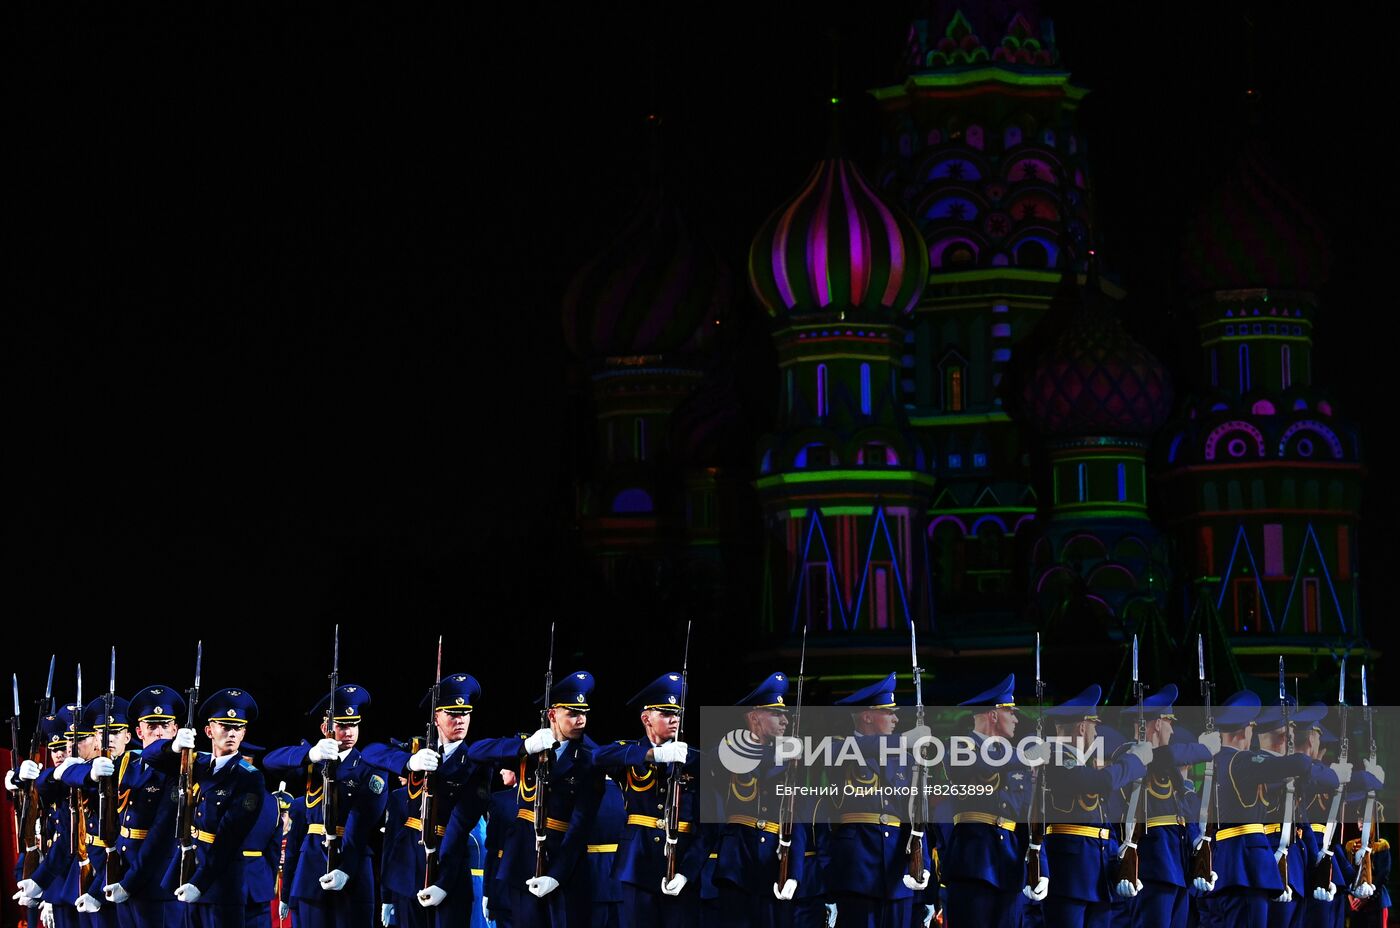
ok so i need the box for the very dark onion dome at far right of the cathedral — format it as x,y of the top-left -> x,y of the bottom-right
1184,143 -> 1331,293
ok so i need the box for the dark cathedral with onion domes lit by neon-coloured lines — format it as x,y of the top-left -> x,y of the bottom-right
564,3 -> 1368,691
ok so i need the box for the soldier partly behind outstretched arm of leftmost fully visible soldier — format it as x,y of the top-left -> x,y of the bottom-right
102,684 -> 185,928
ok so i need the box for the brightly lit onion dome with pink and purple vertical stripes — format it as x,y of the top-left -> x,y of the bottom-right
749,157 -> 928,321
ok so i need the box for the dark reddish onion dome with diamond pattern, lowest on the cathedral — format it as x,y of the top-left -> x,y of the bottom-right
1025,269 -> 1172,438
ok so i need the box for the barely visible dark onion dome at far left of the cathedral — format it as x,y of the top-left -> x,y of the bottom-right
564,189 -> 732,358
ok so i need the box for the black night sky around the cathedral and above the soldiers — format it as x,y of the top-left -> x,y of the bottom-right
10,3 -> 1400,743
